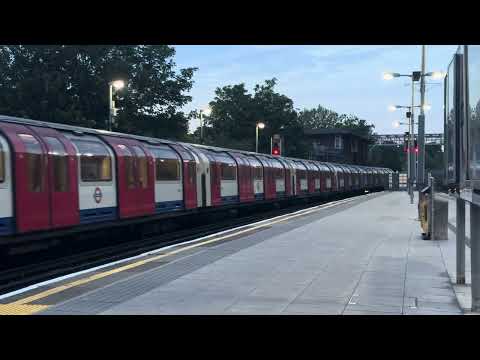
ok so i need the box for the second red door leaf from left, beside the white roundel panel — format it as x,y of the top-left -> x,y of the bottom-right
30,126 -> 80,228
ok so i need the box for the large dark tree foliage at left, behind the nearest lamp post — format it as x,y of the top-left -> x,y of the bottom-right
0,45 -> 195,139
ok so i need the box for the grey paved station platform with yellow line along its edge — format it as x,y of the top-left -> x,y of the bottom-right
0,192 -> 462,315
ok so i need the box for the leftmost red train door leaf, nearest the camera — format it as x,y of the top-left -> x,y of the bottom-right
0,123 -> 50,233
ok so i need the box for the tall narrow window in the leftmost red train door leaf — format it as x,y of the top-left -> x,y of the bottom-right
18,134 -> 45,192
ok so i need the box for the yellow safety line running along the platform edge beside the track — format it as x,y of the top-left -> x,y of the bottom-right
0,194 -> 354,315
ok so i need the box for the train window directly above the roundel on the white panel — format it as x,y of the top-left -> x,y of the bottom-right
72,140 -> 112,182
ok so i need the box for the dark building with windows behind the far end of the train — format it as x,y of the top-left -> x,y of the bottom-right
305,129 -> 370,165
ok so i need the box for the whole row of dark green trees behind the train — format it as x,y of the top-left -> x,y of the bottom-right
0,45 -> 374,157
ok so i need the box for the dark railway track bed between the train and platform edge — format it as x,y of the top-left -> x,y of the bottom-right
0,191 -> 376,295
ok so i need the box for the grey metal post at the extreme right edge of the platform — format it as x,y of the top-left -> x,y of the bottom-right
470,203 -> 480,312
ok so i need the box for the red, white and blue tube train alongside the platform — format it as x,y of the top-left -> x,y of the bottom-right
0,116 -> 392,240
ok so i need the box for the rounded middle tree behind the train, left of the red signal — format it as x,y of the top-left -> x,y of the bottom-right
202,78 -> 308,156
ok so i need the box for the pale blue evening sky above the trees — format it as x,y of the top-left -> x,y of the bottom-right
174,45 -> 457,134
